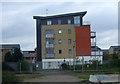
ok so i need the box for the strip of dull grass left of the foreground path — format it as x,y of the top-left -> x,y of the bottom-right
16,74 -> 42,82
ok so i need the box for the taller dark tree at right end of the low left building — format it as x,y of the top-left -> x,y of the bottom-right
13,48 -> 23,62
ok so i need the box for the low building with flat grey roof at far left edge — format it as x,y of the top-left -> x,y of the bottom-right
0,44 -> 20,61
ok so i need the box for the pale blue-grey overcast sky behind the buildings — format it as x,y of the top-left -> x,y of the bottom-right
2,2 -> 118,50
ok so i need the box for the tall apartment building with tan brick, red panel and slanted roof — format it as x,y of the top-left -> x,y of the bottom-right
33,11 -> 102,69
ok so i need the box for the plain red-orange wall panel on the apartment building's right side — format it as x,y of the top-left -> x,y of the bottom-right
75,25 -> 91,56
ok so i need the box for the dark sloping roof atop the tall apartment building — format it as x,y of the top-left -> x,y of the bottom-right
33,11 -> 87,20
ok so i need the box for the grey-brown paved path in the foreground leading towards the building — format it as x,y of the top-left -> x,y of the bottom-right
24,70 -> 82,82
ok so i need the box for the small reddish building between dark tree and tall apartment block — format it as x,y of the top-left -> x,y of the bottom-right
23,51 -> 36,62
